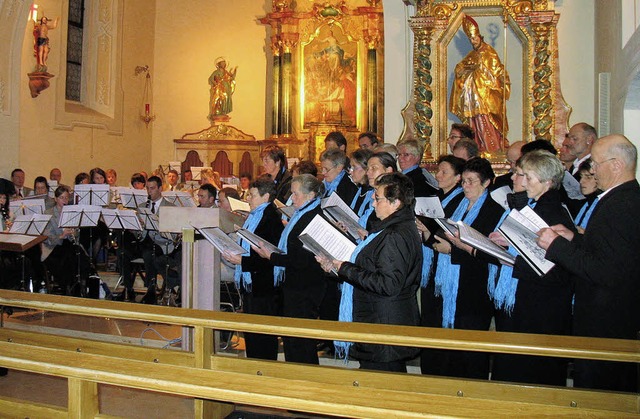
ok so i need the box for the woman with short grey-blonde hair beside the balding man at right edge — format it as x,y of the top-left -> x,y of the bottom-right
490,150 -> 576,386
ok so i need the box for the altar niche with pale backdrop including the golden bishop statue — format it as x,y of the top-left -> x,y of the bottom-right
441,11 -> 530,157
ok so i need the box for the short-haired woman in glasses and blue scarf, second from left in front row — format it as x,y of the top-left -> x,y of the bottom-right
252,174 -> 327,364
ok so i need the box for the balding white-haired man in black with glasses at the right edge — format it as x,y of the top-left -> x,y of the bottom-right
538,135 -> 640,392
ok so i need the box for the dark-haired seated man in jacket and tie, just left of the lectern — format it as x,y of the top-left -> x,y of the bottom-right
141,176 -> 182,302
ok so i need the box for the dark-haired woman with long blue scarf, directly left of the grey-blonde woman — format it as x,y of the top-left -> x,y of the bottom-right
421,157 -> 504,379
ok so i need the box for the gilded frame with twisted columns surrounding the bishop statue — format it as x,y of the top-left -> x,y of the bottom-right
403,0 -> 570,162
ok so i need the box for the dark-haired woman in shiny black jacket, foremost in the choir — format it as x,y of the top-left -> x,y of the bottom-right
317,173 -> 422,372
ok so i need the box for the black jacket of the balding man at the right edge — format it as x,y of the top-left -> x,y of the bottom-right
546,180 -> 640,339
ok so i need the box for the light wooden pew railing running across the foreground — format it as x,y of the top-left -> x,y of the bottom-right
0,291 -> 640,418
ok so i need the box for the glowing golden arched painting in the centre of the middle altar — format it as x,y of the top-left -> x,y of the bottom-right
300,24 -> 360,129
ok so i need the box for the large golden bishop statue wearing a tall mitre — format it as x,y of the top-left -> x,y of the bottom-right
449,15 -> 511,153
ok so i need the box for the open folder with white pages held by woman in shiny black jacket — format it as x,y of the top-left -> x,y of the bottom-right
298,215 -> 356,275
